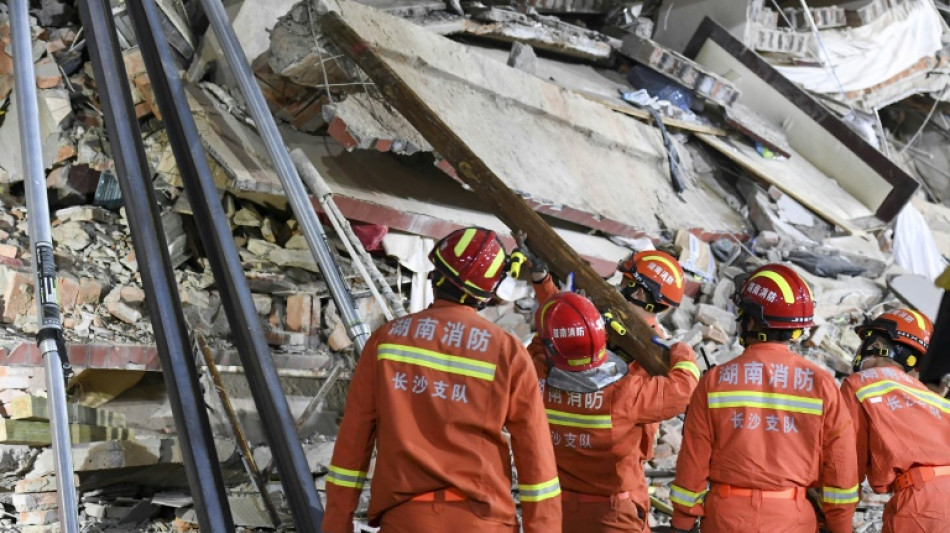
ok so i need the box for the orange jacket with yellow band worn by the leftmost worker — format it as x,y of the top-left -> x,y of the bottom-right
328,300 -> 560,531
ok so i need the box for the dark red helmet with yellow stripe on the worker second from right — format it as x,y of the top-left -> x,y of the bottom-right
736,264 -> 815,329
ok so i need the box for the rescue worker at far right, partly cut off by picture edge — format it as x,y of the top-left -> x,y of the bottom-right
841,309 -> 950,533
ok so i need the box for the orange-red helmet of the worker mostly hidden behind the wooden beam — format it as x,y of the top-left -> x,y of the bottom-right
617,250 -> 686,311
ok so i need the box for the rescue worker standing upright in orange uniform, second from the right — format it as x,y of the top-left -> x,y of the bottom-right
670,264 -> 858,533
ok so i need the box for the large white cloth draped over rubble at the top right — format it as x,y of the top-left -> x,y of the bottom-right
775,0 -> 944,93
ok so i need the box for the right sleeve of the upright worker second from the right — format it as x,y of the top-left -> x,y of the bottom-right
821,380 -> 860,533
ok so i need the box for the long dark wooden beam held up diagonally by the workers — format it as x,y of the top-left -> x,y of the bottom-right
319,11 -> 669,375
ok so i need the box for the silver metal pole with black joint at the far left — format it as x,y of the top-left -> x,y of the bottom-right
7,0 -> 79,533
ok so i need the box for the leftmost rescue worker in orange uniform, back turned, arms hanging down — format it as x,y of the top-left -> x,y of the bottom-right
323,228 -> 561,533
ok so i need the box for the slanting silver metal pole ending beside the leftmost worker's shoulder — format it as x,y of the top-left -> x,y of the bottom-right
201,0 -> 369,357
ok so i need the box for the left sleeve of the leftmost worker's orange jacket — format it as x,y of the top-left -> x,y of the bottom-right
323,335 -> 378,533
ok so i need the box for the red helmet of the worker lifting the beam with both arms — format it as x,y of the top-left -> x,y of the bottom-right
535,292 -> 607,372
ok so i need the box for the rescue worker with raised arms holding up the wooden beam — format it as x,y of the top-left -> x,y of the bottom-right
528,260 -> 699,533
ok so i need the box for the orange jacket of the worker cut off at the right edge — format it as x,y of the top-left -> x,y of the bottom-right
841,367 -> 950,488
